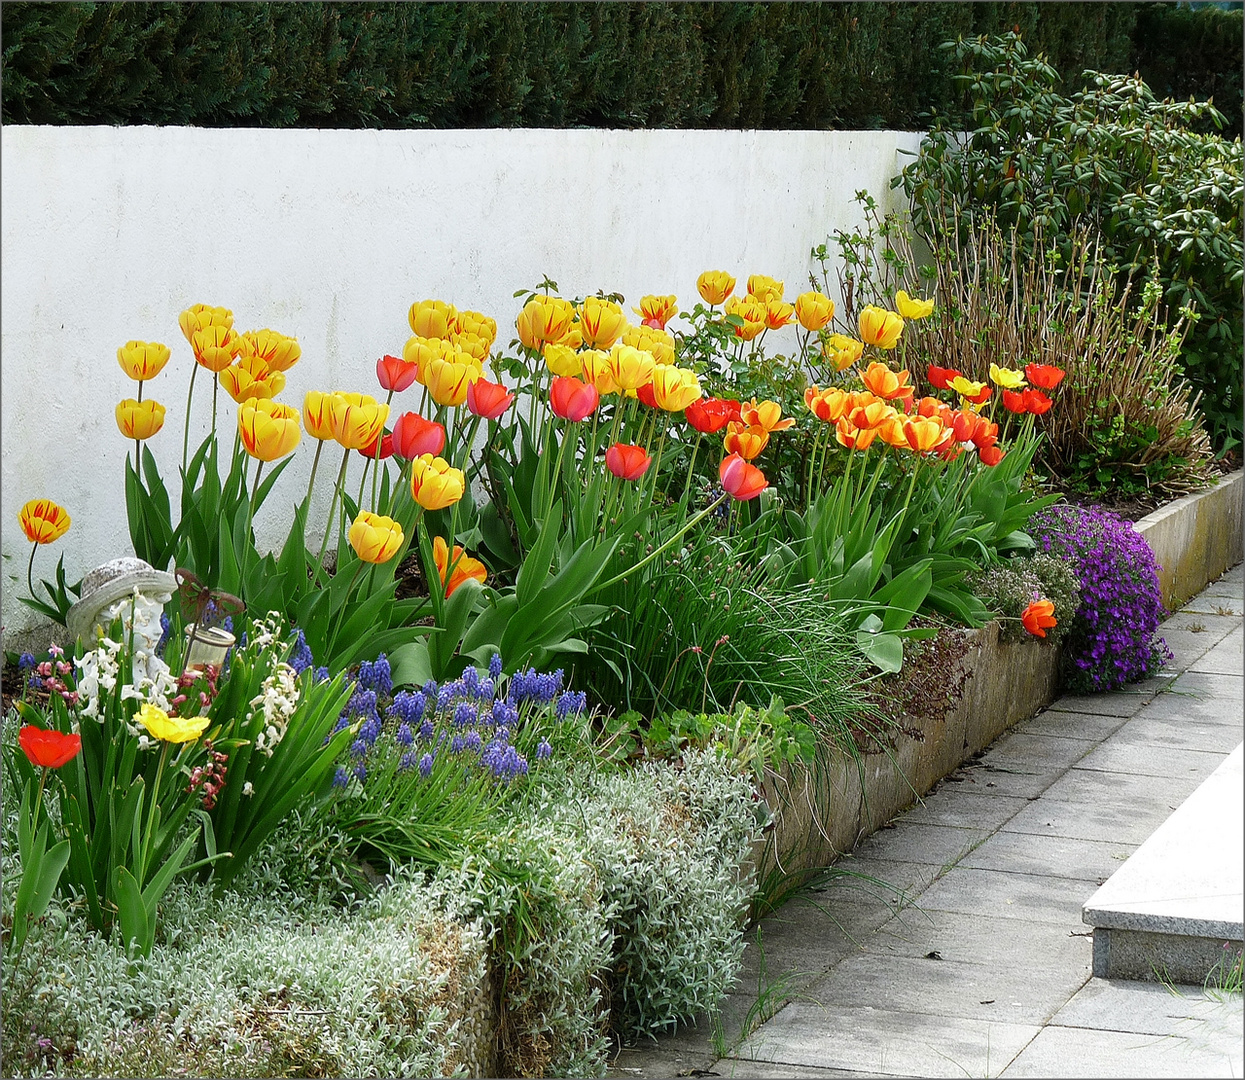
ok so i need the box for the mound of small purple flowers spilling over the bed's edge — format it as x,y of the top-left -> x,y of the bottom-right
1028,503 -> 1172,693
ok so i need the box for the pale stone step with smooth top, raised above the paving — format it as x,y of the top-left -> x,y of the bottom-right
1081,746 -> 1245,984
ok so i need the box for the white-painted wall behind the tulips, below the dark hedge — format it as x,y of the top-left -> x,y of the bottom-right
0,126 -> 919,632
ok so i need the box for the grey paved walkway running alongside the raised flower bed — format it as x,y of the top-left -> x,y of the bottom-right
611,566 -> 1245,1078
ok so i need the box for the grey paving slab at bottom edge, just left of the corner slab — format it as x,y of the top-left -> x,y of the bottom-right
738,1004 -> 1040,1078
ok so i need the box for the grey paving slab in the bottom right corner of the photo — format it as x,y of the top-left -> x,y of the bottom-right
1001,1025 -> 1241,1078
